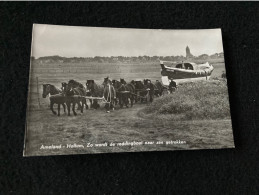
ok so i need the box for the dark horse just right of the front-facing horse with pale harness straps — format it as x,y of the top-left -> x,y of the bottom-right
112,79 -> 135,108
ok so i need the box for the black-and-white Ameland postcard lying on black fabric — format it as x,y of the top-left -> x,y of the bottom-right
24,24 -> 234,156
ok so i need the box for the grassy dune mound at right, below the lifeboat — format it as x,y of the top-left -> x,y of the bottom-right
138,79 -> 233,121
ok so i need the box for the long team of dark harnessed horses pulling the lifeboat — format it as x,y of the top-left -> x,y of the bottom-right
42,77 -> 164,116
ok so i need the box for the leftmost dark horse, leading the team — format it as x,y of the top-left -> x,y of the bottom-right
42,84 -> 66,116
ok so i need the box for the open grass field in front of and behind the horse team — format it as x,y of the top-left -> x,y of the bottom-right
25,62 -> 234,156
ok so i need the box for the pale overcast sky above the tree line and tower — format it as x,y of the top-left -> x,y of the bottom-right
32,24 -> 223,58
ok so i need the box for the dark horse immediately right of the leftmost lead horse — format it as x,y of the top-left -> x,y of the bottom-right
62,82 -> 83,116
